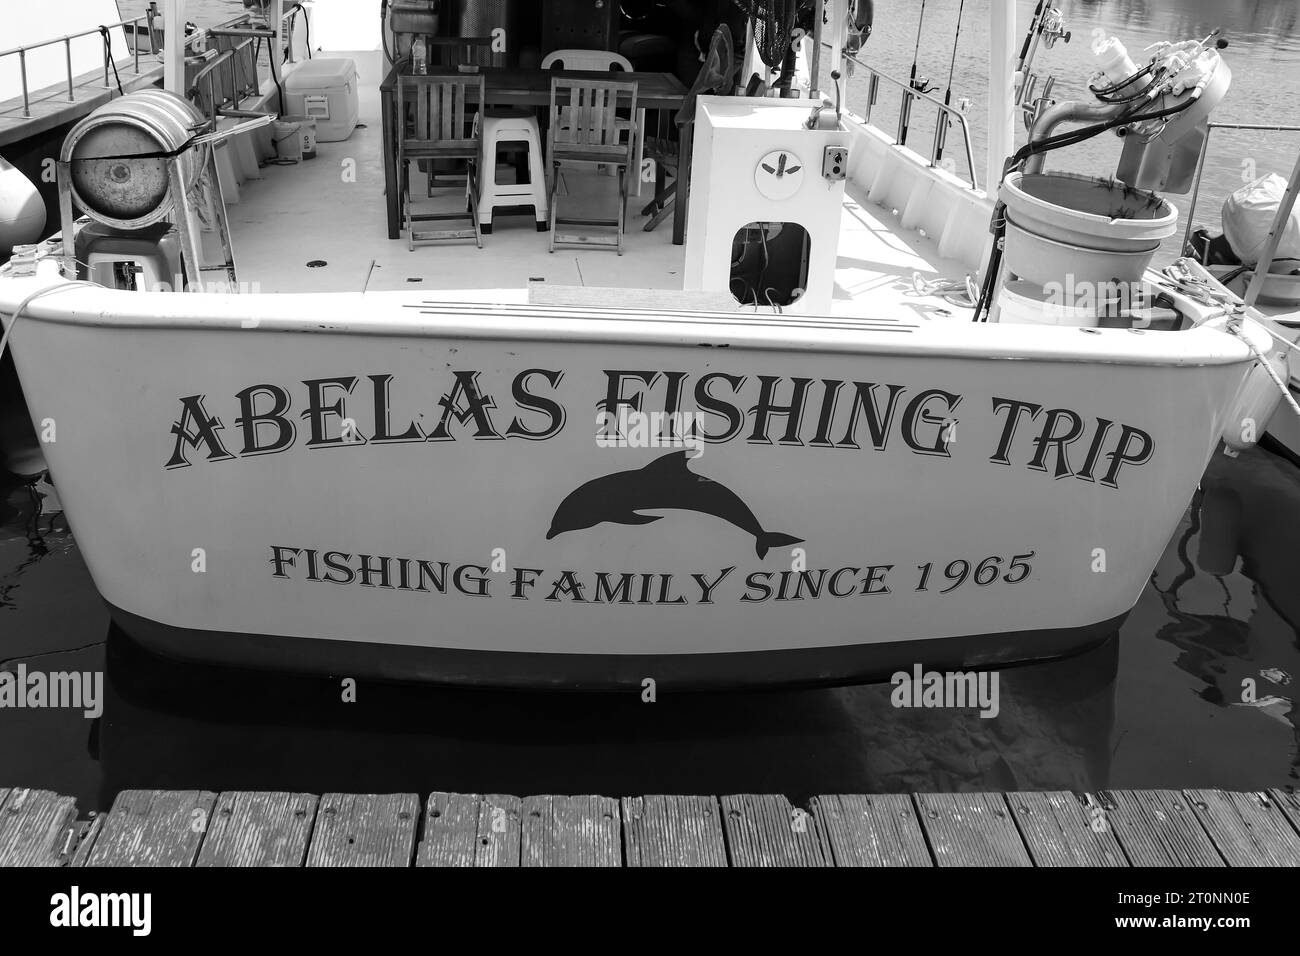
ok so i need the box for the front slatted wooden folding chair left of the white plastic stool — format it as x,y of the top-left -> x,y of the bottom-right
397,74 -> 484,250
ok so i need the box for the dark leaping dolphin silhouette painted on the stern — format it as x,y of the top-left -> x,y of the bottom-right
546,451 -> 803,558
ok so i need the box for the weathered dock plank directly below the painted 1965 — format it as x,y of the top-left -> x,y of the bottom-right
915,793 -> 1034,866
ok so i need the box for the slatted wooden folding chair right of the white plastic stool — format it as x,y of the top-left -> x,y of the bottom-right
546,77 -> 637,255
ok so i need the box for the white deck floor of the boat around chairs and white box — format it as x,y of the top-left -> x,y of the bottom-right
229,53 -> 969,321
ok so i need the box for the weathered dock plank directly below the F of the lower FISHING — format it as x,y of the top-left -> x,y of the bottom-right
196,792 -> 319,866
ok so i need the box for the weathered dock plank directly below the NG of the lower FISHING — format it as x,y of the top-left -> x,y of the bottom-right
416,792 -> 523,866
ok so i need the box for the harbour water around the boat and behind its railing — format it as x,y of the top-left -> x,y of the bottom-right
0,0 -> 1300,809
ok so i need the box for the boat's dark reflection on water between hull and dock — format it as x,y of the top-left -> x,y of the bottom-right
96,632 -> 1118,804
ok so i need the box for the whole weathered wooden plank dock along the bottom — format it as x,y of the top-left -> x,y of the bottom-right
0,788 -> 1300,866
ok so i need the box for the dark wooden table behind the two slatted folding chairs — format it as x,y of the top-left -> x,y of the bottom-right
380,66 -> 690,246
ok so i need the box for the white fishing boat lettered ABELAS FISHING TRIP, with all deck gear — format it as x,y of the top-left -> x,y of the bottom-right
0,0 -> 1286,693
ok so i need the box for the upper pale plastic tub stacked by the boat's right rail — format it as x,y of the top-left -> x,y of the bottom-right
998,173 -> 1178,285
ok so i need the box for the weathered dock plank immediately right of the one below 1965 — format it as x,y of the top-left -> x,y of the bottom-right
1006,791 -> 1128,866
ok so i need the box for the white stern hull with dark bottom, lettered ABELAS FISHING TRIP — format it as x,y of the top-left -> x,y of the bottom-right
0,282 -> 1249,688
